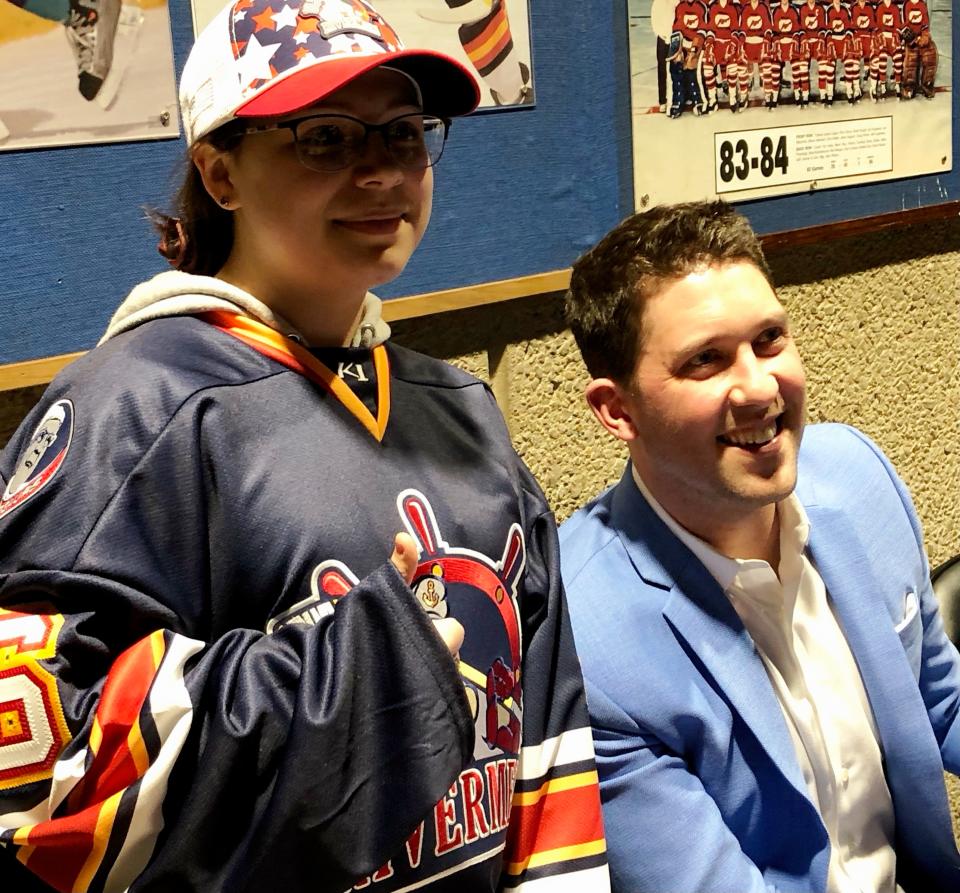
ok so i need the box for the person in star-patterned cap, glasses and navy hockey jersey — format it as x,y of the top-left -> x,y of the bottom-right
0,0 -> 606,891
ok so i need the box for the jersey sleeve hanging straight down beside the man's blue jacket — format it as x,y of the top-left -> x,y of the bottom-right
501,469 -> 609,893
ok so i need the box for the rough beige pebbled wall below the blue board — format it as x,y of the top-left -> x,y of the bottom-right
0,213 -> 960,813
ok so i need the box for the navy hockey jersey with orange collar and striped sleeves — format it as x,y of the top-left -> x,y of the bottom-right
0,272 -> 607,893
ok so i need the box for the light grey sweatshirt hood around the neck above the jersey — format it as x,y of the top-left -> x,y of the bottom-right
99,270 -> 390,347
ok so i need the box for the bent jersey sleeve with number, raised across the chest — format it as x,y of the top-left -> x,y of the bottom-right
0,394 -> 473,893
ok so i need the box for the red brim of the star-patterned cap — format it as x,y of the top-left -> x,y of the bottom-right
235,50 -> 480,118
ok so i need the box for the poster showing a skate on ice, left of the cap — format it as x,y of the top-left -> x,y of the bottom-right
0,0 -> 180,151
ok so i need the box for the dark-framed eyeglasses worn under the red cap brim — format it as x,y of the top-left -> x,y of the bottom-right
241,112 -> 450,173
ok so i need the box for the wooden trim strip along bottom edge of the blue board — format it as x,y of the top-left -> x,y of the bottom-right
0,201 -> 960,392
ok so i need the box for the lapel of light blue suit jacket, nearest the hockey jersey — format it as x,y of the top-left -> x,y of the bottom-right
612,467 -> 809,797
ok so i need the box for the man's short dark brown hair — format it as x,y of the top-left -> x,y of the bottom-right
565,202 -> 773,383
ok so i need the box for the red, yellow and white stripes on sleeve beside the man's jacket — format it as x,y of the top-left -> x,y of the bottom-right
504,728 -> 606,893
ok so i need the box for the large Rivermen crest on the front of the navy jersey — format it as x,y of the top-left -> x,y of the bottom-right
267,489 -> 526,893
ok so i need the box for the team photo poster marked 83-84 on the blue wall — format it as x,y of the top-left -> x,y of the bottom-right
628,0 -> 953,208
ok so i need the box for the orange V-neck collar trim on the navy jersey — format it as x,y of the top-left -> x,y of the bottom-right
198,310 -> 390,442
